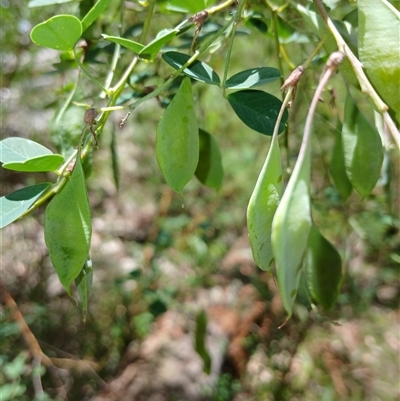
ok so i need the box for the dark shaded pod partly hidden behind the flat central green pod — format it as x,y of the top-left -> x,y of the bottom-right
195,129 -> 224,191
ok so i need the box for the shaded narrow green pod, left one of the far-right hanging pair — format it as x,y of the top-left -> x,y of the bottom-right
329,122 -> 353,200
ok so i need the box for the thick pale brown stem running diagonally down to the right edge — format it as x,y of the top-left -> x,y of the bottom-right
313,0 -> 400,149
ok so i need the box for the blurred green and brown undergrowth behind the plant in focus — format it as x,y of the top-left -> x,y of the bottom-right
0,0 -> 400,401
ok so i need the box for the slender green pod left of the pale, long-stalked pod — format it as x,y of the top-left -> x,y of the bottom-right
247,136 -> 283,271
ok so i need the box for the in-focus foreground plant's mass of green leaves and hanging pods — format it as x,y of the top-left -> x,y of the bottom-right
0,0 -> 400,326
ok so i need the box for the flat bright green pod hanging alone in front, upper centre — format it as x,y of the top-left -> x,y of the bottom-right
156,78 -> 199,193
